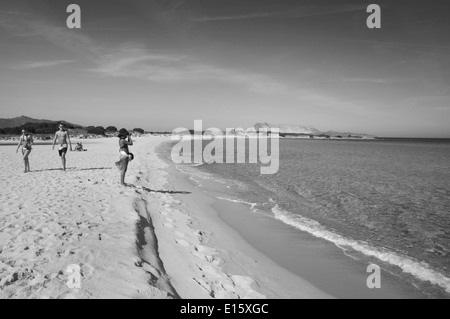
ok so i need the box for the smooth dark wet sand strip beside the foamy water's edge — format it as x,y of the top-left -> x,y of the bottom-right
155,141 -> 432,299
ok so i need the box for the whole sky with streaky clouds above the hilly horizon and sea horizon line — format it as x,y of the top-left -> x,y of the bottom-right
0,0 -> 450,138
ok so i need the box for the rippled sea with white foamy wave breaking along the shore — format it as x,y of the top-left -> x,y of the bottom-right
160,139 -> 450,296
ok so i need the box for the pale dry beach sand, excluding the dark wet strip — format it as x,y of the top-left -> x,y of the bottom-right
0,137 -> 330,299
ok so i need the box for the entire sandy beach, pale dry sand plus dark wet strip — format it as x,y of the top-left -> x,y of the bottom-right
0,136 -> 442,299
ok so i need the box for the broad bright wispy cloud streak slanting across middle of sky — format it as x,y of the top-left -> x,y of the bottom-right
91,47 -> 362,115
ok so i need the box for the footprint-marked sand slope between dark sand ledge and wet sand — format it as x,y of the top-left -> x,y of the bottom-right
133,139 -> 331,299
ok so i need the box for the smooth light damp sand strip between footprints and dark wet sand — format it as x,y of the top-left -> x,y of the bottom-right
156,150 -> 333,299
